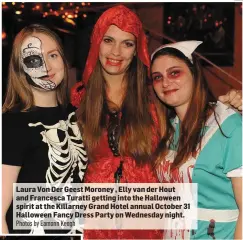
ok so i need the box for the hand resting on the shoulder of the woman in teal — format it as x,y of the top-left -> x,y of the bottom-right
219,89 -> 242,111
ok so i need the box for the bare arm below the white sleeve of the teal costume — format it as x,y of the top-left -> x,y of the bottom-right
231,177 -> 243,239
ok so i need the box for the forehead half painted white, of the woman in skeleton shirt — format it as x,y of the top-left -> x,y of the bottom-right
21,33 -> 58,52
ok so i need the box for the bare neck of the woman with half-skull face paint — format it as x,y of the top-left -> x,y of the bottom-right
31,87 -> 58,107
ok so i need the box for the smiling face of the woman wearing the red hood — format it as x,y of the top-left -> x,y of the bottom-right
99,25 -> 136,77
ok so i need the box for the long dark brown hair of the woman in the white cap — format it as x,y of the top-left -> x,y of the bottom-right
151,48 -> 217,169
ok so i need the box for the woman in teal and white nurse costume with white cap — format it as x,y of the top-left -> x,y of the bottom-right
151,41 -> 242,239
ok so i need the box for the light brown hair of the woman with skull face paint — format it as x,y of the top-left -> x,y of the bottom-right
2,24 -> 68,112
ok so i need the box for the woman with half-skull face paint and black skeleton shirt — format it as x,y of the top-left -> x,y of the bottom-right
2,24 -> 87,234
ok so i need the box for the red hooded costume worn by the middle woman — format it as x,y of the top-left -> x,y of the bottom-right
71,5 -> 162,239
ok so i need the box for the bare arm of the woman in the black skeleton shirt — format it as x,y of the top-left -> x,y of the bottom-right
2,164 -> 21,234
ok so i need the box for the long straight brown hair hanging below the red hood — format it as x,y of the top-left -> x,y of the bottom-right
78,56 -> 166,164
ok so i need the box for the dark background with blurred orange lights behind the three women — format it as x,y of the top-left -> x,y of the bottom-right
2,2 -> 242,100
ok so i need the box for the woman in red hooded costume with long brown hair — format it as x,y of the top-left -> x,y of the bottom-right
71,5 -> 241,239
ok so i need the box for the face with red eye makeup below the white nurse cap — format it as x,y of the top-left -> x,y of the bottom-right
151,55 -> 194,111
